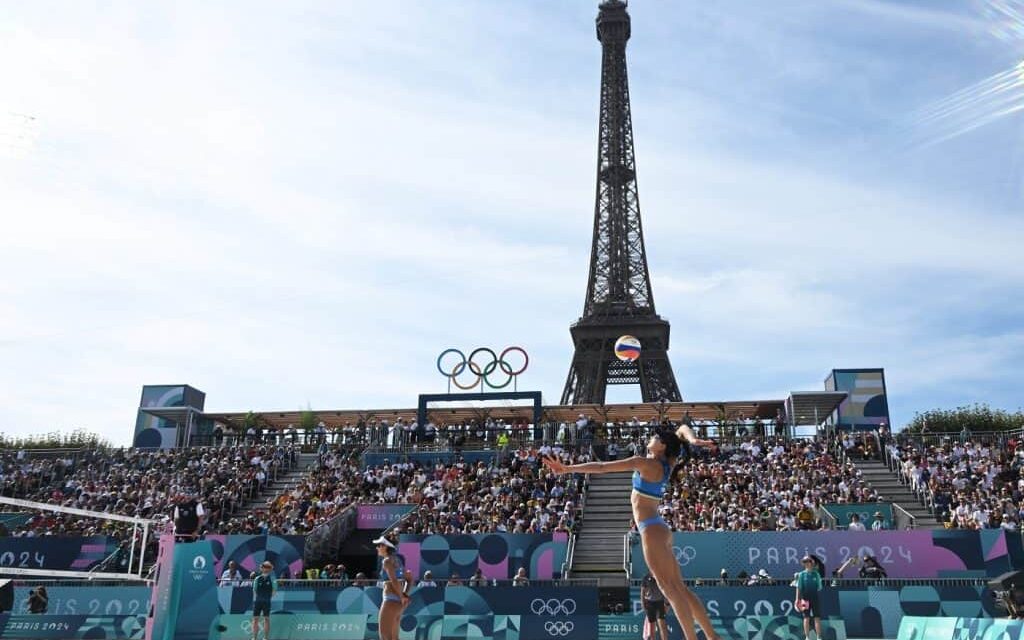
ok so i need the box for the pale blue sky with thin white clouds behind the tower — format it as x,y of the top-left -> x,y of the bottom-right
0,0 -> 1024,442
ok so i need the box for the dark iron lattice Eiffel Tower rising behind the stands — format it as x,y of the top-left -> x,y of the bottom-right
562,0 -> 682,404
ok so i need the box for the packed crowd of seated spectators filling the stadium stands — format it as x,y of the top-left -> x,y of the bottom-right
9,417 -> 1024,539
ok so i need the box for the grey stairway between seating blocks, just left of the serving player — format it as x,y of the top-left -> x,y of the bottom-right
570,471 -> 633,573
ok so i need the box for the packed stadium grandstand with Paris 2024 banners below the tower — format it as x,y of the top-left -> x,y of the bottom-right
0,372 -> 1024,638
